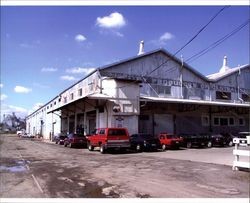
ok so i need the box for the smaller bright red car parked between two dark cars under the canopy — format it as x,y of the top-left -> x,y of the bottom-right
159,133 -> 183,150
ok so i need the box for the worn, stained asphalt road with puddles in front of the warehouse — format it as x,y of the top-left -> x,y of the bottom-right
0,135 -> 249,198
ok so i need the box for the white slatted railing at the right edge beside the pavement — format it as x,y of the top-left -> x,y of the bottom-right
233,136 -> 250,170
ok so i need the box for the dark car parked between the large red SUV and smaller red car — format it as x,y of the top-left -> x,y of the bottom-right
130,133 -> 161,152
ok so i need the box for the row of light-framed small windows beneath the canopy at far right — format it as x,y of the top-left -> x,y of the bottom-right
202,116 -> 245,126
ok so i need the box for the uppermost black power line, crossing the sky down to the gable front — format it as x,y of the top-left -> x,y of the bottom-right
143,6 -> 230,77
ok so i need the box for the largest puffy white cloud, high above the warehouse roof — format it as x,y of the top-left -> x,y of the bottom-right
96,12 -> 126,28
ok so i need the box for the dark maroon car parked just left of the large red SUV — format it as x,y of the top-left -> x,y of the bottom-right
64,133 -> 87,147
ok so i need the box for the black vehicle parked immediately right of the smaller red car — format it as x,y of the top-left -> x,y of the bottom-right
180,133 -> 212,148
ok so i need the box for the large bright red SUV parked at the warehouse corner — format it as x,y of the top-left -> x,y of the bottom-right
87,128 -> 130,153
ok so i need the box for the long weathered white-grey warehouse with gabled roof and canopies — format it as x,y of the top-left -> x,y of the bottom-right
26,43 -> 250,139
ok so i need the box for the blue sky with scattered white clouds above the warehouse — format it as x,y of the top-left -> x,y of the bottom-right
0,6 -> 249,118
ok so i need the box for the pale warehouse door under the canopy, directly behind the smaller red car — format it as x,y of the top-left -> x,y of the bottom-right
154,114 -> 174,135
